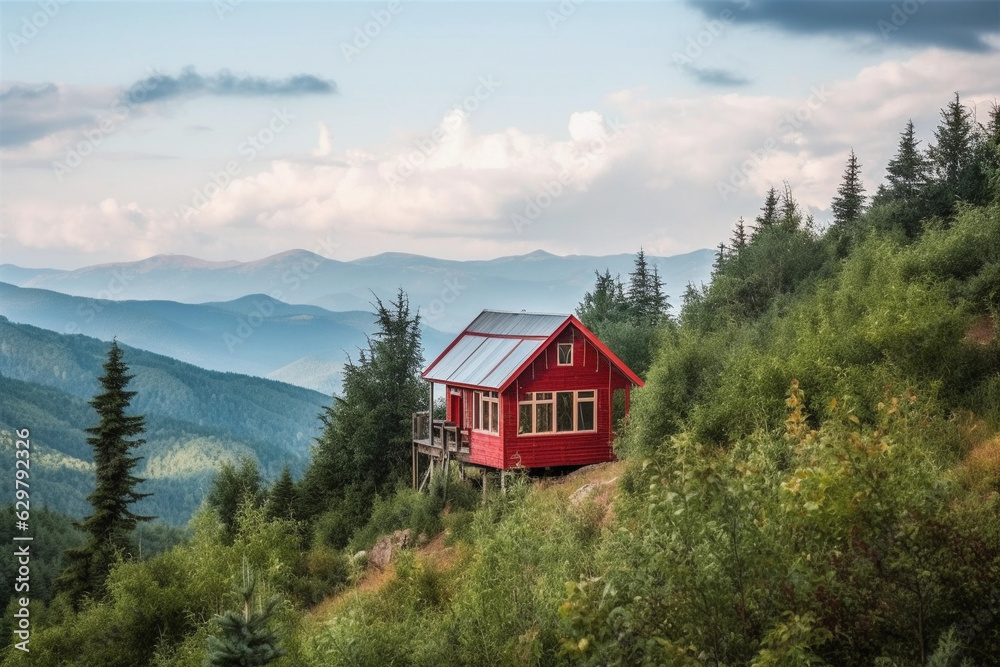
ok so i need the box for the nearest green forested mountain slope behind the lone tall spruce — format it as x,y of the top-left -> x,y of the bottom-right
0,317 -> 330,523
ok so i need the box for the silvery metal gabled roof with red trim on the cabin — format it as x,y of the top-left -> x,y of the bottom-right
421,310 -> 642,389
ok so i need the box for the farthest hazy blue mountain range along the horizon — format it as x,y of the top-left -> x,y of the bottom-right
0,250 -> 713,332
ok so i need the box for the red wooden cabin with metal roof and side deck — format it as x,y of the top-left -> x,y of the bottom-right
413,310 -> 643,483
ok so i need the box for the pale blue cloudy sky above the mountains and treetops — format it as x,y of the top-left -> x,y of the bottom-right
0,0 -> 1000,269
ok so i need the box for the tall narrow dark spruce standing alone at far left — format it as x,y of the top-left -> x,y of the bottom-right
56,341 -> 153,604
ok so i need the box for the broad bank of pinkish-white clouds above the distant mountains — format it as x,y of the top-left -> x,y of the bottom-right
3,45 -> 1000,266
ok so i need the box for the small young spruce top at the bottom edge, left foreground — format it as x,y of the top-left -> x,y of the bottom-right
202,570 -> 285,667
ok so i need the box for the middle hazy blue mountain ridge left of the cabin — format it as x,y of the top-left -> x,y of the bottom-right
0,283 -> 451,396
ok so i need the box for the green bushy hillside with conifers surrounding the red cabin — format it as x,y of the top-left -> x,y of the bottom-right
4,96 -> 1000,667
